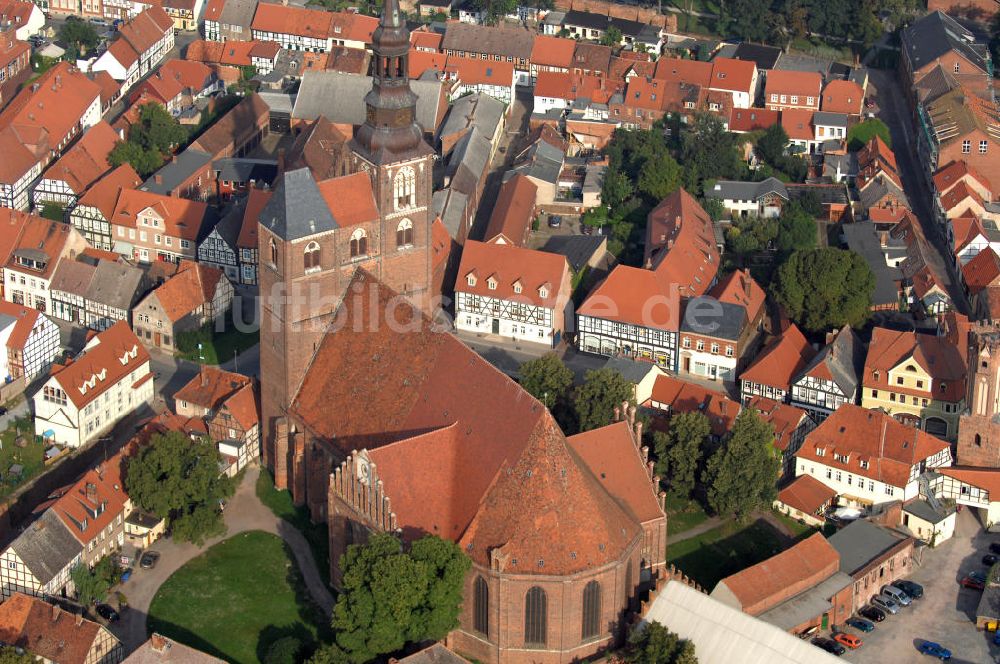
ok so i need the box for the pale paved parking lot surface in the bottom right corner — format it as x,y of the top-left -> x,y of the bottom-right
844,509 -> 1000,664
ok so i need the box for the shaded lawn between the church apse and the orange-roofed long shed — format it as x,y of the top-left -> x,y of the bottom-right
667,520 -> 785,592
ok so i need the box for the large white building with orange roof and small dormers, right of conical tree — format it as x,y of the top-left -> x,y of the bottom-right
795,404 -> 952,506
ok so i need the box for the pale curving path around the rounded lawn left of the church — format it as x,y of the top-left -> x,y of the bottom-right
111,467 -> 334,653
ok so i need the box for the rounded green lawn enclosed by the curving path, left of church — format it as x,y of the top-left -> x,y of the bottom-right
147,531 -> 329,664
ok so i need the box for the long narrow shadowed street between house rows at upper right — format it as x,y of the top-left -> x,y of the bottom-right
868,69 -> 969,314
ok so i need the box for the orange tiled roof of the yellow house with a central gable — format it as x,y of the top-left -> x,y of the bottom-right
862,327 -> 965,401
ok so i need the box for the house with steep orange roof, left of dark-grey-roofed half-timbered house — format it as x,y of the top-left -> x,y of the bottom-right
740,323 -> 816,403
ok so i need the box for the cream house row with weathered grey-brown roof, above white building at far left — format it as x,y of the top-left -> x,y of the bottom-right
50,250 -> 146,332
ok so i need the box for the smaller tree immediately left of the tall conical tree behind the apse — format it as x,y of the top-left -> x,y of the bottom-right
653,411 -> 712,498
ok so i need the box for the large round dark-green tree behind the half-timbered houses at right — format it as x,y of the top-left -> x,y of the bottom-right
771,247 -> 875,332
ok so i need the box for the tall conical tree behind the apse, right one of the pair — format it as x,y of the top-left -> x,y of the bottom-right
704,408 -> 781,520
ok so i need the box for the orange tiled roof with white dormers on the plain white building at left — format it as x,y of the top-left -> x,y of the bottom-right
52,320 -> 149,409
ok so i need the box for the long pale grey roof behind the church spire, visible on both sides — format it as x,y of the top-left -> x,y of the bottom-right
292,71 -> 441,132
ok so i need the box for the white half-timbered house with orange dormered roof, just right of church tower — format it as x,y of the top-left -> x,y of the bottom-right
455,240 -> 572,347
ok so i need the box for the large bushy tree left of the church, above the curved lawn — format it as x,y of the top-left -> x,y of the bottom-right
125,431 -> 235,545
